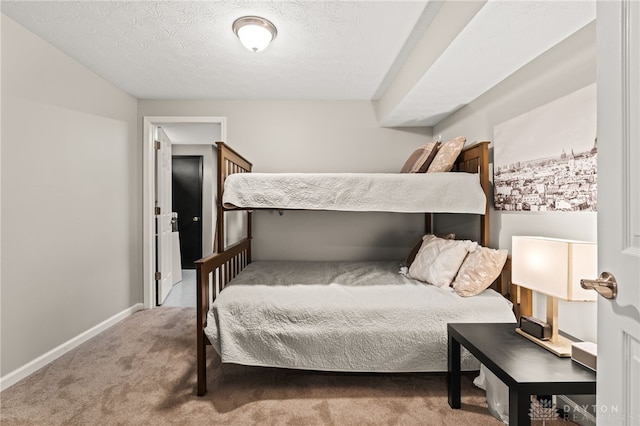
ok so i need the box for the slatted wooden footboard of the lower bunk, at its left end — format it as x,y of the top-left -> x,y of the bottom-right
195,238 -> 251,396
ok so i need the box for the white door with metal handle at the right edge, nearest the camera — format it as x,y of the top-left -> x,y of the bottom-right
596,0 -> 640,426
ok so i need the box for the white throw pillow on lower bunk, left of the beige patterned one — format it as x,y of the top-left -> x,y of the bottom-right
409,235 -> 478,287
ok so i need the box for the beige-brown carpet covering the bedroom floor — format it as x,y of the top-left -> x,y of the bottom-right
0,307 -> 564,425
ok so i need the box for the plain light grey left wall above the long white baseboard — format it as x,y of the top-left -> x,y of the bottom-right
0,15 -> 142,377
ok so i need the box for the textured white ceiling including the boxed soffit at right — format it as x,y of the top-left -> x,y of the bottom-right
0,0 -> 595,126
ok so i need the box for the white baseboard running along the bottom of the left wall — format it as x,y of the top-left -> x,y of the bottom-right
0,303 -> 143,391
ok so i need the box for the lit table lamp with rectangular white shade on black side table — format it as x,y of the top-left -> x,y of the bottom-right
511,236 -> 598,357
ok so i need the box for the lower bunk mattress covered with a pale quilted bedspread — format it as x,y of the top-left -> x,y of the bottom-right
205,261 -> 515,372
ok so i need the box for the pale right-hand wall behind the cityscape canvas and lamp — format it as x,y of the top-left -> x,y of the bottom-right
433,24 -> 597,341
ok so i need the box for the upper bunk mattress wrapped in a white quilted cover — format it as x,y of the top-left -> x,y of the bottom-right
222,172 -> 487,214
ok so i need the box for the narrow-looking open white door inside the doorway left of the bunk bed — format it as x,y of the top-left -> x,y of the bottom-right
156,128 -> 173,305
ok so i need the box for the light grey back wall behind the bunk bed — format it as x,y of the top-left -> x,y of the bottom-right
138,100 -> 431,260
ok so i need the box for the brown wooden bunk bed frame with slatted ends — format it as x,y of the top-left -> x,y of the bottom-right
195,142 -> 532,396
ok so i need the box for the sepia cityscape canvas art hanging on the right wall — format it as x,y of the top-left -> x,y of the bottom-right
493,84 -> 598,212
